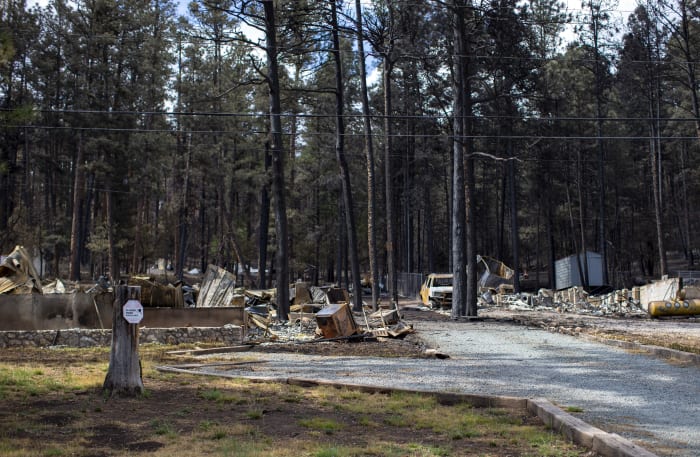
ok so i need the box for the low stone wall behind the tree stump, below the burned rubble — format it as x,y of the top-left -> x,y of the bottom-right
0,325 -> 243,348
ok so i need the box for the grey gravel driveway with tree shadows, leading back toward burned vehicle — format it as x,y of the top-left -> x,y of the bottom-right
208,321 -> 700,457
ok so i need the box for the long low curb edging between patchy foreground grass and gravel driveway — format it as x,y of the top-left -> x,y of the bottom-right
156,366 -> 658,457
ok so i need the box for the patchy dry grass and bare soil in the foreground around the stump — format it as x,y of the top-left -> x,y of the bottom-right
0,346 -> 589,457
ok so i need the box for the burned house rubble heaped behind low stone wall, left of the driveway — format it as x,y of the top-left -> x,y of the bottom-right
0,246 -> 412,350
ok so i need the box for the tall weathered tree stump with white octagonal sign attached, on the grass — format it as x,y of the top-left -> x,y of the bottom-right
102,286 -> 144,397
